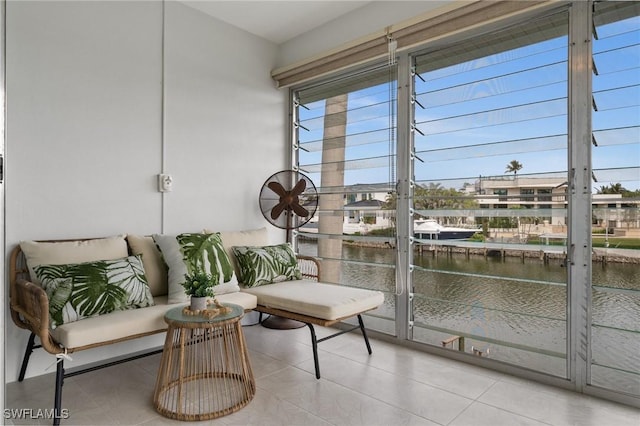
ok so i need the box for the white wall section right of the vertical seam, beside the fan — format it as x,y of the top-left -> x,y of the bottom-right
165,2 -> 288,232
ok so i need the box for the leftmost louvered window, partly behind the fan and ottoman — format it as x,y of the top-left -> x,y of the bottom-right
293,65 -> 397,334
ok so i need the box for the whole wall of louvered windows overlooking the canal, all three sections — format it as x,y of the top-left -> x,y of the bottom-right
291,1 -> 640,400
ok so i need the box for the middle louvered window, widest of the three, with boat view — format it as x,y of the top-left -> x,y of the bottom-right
412,9 -> 568,377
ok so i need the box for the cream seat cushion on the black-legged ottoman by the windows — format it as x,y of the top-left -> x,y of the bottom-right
242,280 -> 384,320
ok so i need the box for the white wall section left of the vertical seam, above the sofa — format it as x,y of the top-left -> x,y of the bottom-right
6,1 -> 162,240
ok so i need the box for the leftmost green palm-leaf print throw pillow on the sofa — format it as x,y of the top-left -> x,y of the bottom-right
34,255 -> 153,329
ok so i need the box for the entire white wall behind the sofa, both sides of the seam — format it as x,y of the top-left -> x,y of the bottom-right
5,1 -> 287,382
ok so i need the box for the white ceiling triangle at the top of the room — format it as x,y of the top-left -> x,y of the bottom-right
182,0 -> 371,44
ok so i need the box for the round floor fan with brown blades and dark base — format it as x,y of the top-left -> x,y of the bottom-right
258,170 -> 318,329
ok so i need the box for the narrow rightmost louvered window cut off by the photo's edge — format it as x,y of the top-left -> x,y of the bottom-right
591,1 -> 640,395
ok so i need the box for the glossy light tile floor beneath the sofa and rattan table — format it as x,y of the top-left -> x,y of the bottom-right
5,326 -> 640,426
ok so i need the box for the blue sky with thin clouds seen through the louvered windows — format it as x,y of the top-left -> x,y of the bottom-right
299,10 -> 640,192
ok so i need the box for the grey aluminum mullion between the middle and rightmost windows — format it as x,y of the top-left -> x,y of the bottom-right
567,1 -> 593,392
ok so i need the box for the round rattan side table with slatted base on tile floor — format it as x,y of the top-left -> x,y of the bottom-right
153,304 -> 256,420
